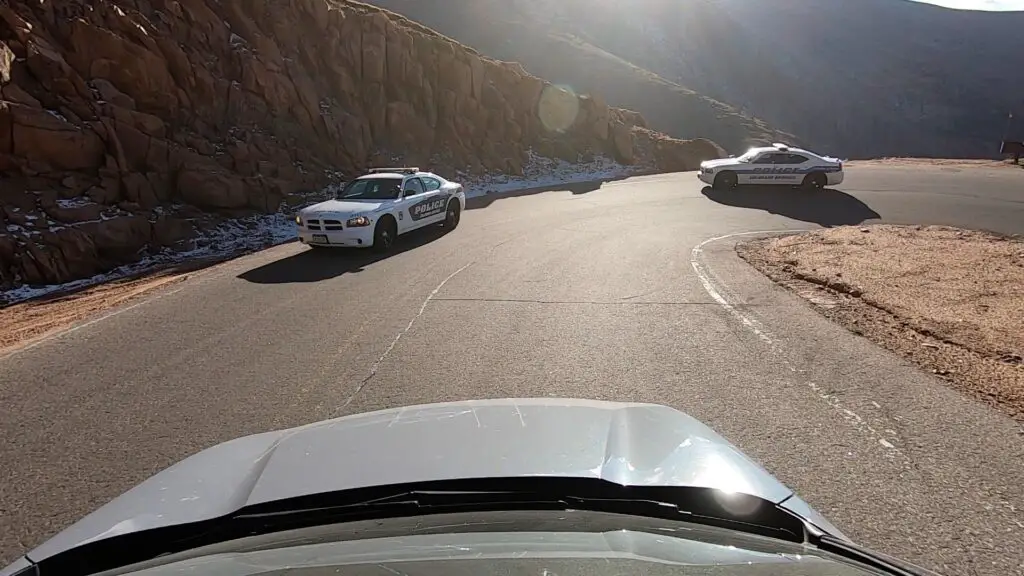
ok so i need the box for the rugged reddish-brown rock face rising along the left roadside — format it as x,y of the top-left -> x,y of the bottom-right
0,0 -> 719,289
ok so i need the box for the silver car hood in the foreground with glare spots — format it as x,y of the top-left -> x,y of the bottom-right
22,399 -> 842,561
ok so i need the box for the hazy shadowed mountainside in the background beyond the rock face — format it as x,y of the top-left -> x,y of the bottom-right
368,0 -> 1024,158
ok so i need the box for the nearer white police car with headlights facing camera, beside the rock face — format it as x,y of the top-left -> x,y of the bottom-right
295,168 -> 466,252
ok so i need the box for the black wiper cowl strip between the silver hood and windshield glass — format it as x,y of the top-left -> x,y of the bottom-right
37,477 -> 808,576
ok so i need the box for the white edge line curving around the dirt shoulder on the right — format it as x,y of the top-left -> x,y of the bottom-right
690,230 -> 907,460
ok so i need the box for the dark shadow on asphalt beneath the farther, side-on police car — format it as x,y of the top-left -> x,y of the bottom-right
700,186 -> 882,228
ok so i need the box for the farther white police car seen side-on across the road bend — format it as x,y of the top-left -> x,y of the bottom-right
697,143 -> 843,190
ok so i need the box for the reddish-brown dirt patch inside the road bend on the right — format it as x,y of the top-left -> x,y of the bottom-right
736,225 -> 1024,421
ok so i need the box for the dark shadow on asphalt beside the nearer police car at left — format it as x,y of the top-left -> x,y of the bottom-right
238,225 -> 446,284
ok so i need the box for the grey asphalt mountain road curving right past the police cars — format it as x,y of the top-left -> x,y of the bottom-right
6,163 -> 1024,575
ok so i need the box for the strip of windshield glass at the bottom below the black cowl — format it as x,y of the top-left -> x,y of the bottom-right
105,510 -> 888,576
